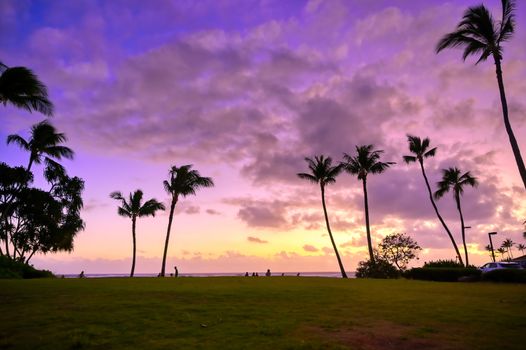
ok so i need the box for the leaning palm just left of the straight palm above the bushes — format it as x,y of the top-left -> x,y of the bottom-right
297,155 -> 347,278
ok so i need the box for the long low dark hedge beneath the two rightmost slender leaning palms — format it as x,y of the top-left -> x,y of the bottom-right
404,267 -> 481,282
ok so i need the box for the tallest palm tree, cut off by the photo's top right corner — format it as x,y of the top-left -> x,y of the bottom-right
436,0 -> 526,188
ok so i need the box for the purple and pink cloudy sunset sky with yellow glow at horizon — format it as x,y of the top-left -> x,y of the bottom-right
0,0 -> 526,273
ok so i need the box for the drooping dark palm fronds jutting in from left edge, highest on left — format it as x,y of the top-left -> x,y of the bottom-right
0,62 -> 53,116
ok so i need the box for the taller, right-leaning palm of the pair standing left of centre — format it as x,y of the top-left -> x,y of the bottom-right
161,165 -> 214,276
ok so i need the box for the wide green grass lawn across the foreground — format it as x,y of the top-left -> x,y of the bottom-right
0,277 -> 526,350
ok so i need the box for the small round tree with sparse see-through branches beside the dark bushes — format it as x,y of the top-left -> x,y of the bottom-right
378,233 -> 422,271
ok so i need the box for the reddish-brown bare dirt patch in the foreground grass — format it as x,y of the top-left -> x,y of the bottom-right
297,321 -> 459,350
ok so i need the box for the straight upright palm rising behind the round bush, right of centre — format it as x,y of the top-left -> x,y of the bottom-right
343,145 -> 395,263
